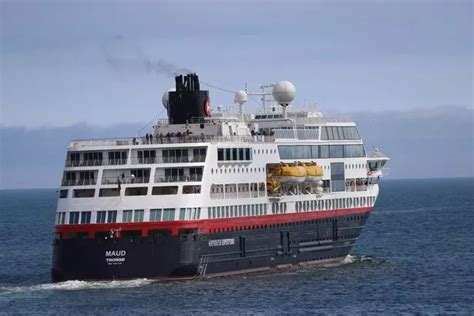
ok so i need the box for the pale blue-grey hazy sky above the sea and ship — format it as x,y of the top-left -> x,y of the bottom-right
0,0 -> 474,187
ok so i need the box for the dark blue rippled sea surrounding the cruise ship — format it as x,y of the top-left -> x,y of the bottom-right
0,178 -> 474,314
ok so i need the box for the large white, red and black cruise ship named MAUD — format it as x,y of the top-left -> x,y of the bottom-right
51,74 -> 389,281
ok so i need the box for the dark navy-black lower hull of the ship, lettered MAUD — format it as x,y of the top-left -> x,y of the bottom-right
52,212 -> 370,281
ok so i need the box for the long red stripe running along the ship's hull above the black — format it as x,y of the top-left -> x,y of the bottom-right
54,207 -> 372,238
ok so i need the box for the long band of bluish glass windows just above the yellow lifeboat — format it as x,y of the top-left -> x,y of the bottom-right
278,145 -> 365,159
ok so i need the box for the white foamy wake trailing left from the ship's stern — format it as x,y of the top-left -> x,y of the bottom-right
0,279 -> 154,294
